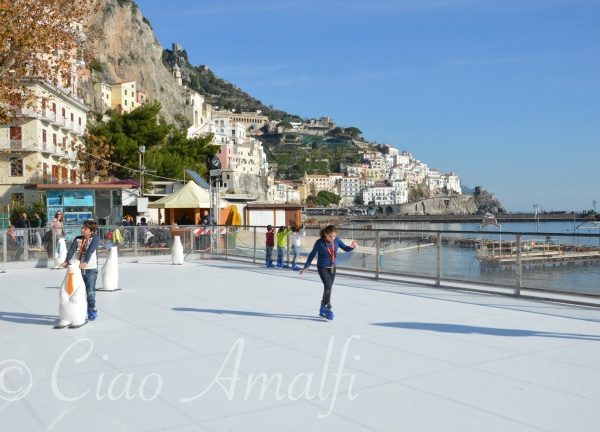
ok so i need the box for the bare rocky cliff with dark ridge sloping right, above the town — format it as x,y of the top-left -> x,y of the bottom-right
82,0 -> 300,123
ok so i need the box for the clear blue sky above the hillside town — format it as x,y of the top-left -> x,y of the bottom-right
137,0 -> 600,211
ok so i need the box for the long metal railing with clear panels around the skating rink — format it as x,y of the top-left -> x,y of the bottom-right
0,225 -> 600,306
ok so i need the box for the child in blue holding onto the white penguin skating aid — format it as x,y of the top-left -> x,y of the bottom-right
61,220 -> 99,321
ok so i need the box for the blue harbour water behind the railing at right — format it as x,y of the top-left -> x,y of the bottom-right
340,221 -> 600,295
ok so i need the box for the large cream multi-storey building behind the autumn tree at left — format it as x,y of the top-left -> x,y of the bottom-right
0,82 -> 89,203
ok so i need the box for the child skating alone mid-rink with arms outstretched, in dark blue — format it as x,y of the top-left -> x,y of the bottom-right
300,225 -> 356,320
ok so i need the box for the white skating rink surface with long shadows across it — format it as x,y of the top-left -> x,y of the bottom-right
0,257 -> 600,432
